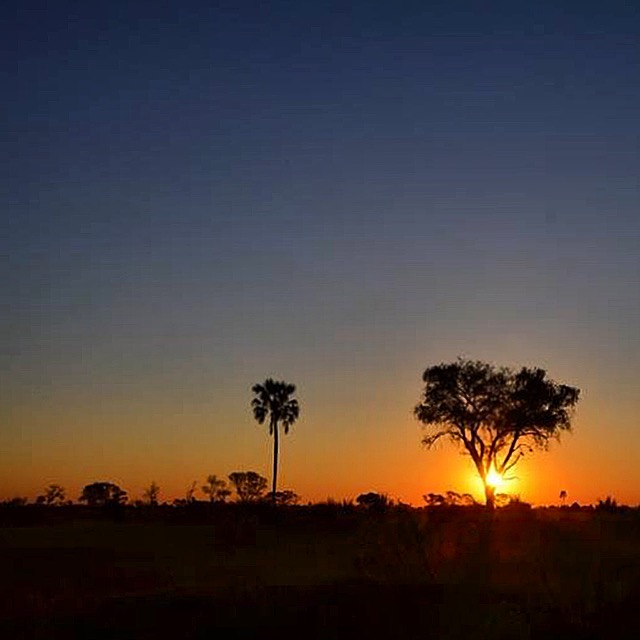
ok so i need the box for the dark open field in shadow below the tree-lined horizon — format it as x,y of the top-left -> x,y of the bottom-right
0,505 -> 640,638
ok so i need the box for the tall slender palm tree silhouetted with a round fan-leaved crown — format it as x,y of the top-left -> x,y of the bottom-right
251,378 -> 300,504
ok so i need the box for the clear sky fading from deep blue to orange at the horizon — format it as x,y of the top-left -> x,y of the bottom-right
0,0 -> 640,505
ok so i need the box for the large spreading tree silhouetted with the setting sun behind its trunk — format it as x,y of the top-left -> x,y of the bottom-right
414,358 -> 580,508
